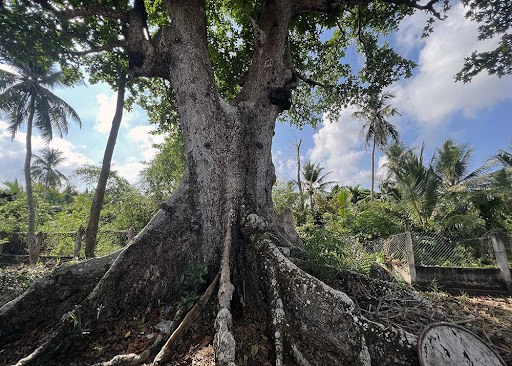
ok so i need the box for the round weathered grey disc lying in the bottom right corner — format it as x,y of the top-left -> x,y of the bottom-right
418,323 -> 505,366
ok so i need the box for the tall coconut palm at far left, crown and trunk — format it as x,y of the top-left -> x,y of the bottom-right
0,62 -> 81,264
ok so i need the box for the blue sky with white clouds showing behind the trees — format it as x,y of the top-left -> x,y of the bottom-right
0,5 -> 512,187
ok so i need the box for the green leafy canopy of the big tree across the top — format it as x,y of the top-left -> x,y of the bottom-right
0,0 -> 512,132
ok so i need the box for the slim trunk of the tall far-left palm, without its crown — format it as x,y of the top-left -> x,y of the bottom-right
24,95 -> 40,264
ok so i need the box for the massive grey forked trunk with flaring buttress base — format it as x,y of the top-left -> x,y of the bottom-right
0,0 -> 428,366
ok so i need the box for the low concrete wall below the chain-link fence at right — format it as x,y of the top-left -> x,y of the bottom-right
416,266 -> 506,290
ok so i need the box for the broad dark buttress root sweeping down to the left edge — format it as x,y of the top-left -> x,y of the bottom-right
0,184 -> 204,365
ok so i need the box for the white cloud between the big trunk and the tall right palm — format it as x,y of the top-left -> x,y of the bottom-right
308,107 -> 371,185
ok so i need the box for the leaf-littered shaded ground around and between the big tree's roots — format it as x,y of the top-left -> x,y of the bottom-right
0,262 -> 512,366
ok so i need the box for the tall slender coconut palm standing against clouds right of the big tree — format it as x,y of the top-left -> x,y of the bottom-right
352,92 -> 400,200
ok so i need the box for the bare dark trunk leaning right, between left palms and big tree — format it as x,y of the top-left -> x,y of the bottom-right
85,74 -> 126,258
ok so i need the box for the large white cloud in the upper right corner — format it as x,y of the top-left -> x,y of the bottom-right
393,3 -> 512,124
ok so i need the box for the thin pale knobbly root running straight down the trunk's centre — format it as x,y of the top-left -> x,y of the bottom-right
213,210 -> 236,366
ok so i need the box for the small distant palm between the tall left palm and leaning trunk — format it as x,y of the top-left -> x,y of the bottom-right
31,148 -> 68,202
